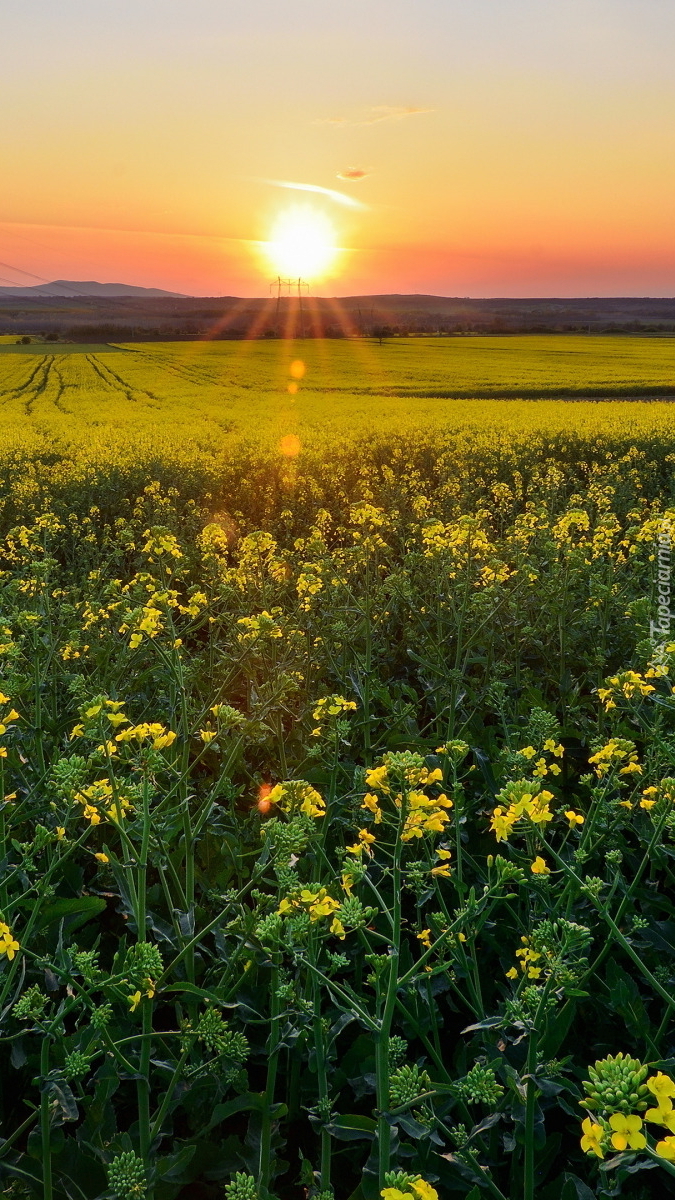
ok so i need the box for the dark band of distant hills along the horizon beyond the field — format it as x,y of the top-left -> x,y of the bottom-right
0,290 -> 675,343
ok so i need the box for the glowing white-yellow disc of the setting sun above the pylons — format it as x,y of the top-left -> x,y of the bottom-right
264,205 -> 339,280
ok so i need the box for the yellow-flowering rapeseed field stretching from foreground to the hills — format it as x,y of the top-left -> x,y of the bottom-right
0,337 -> 675,1200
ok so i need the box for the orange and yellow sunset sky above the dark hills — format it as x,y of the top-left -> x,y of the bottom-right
0,0 -> 675,296
